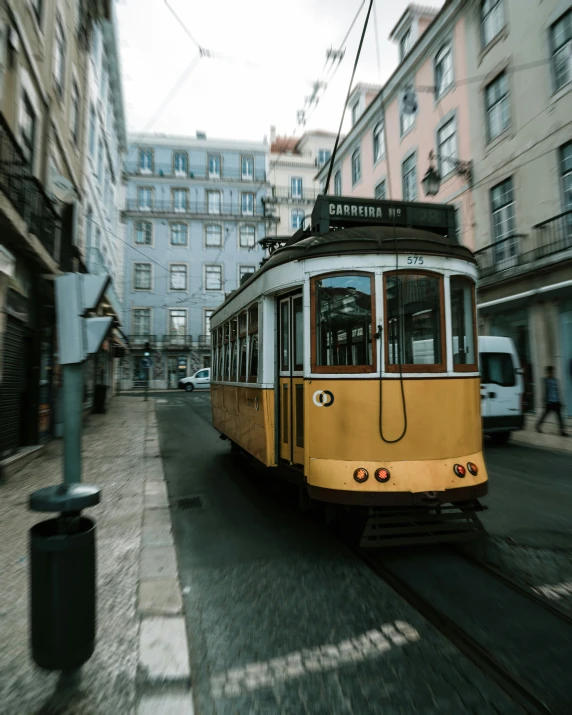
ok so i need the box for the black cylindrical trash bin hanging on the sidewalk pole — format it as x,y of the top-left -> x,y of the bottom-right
30,516 -> 96,670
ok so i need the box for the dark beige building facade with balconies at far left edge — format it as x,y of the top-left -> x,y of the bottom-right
0,0 -> 119,461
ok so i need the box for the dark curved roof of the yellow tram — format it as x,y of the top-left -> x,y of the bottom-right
215,226 -> 476,313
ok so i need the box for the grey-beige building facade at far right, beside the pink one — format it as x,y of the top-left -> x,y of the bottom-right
465,0 -> 572,415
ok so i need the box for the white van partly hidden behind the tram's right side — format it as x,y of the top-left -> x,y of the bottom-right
479,336 -> 524,443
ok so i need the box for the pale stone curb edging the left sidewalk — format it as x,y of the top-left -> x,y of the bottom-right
137,400 -> 193,715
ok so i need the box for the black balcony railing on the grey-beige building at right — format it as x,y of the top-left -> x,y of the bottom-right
475,210 -> 572,278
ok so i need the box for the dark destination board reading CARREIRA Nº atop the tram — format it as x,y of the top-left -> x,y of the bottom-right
311,194 -> 458,243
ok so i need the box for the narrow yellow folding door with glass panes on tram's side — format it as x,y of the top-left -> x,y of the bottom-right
278,294 -> 304,465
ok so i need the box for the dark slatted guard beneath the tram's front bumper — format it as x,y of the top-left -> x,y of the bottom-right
360,504 -> 484,548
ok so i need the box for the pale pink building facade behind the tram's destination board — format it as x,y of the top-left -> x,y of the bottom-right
317,0 -> 474,247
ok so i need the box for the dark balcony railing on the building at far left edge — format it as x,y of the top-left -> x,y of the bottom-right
0,114 -> 59,258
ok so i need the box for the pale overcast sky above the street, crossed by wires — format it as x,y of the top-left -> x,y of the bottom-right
117,0 -> 443,141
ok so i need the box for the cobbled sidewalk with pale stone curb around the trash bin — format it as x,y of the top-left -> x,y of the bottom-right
0,397 -> 193,715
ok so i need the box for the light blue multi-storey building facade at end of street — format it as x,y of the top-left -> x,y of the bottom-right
122,133 -> 276,389
